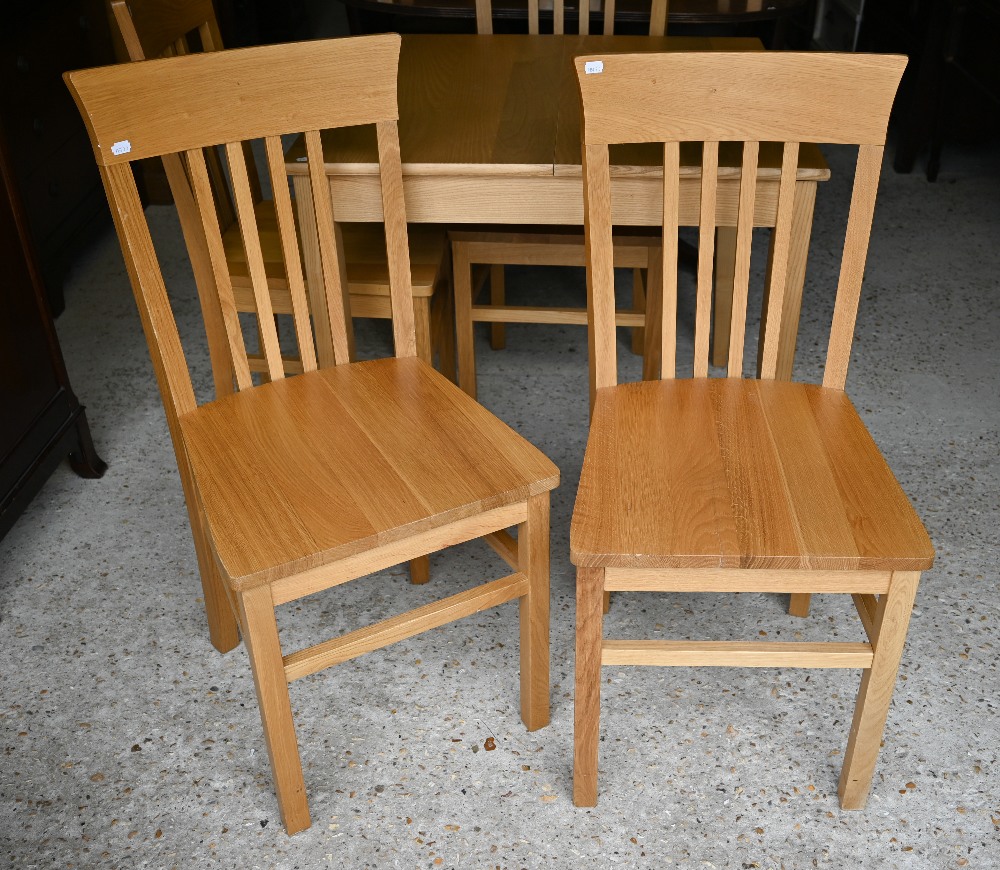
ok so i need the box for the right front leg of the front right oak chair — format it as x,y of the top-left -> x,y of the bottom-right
837,571 -> 920,810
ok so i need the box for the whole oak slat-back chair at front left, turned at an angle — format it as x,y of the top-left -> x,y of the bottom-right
66,34 -> 558,833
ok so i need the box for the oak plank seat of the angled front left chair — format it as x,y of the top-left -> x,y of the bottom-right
179,358 -> 559,589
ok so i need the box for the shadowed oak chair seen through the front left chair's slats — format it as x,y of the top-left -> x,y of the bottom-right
111,0 -> 455,392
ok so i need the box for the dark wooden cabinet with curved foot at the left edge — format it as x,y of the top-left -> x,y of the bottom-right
0,118 -> 106,537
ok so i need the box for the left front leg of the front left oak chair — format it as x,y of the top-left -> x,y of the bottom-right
238,586 -> 311,834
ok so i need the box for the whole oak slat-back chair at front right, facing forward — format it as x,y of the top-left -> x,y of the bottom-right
570,52 -> 934,809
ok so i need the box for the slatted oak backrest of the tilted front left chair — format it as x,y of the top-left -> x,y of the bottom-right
65,34 -> 416,426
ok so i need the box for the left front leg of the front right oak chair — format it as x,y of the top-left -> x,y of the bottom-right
573,568 -> 604,807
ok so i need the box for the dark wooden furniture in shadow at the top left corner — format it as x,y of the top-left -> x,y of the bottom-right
0,0 -> 115,314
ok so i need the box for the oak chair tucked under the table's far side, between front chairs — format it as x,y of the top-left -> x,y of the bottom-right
451,0 -> 667,398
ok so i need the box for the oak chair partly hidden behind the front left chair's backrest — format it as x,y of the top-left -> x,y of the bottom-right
111,0 -> 455,583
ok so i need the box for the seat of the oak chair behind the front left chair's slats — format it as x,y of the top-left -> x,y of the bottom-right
222,200 -> 448,304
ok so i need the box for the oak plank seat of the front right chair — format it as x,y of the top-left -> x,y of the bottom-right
570,378 -> 934,571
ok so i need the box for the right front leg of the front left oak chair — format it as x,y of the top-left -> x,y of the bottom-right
517,492 -> 549,731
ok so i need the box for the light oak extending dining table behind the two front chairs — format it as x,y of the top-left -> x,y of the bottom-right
286,34 -> 830,379
